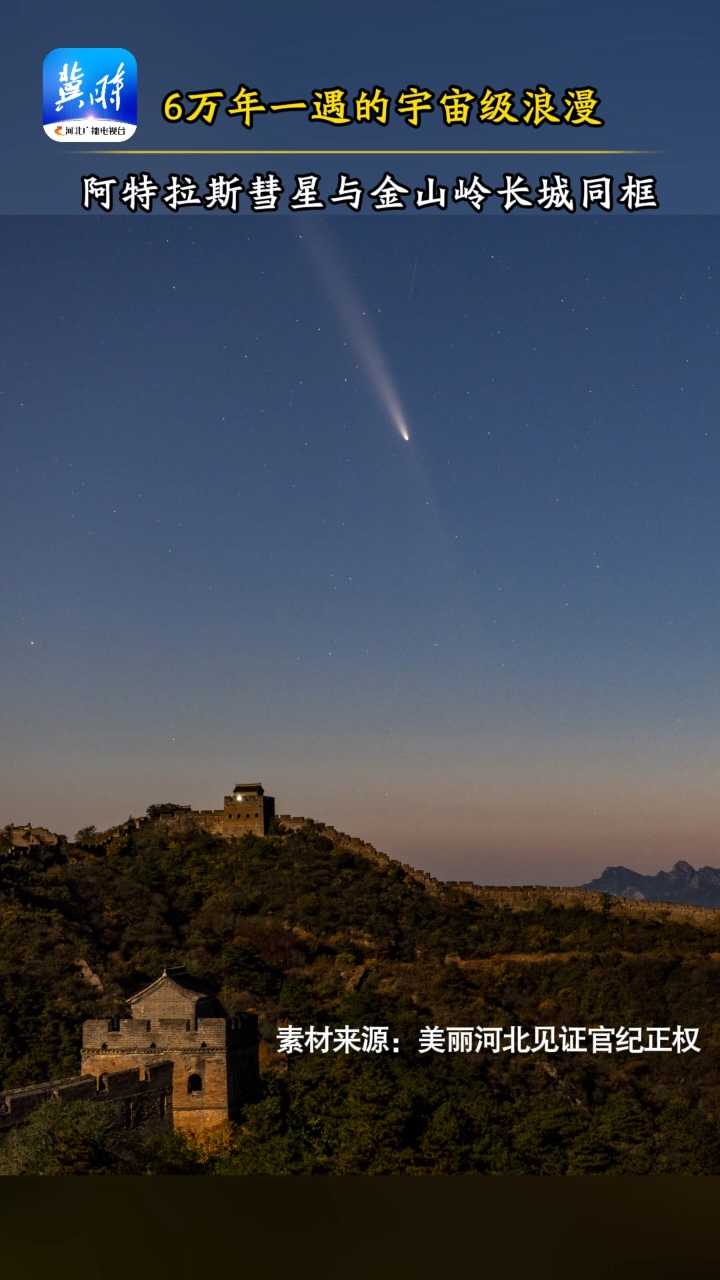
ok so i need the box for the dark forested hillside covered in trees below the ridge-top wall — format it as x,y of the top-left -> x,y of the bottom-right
0,822 -> 720,1174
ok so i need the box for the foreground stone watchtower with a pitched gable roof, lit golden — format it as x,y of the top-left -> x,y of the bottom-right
82,969 -> 258,1133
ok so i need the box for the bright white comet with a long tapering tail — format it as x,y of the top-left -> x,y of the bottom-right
301,232 -> 410,444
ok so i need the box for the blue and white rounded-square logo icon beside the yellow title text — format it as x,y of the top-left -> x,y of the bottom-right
42,49 -> 137,143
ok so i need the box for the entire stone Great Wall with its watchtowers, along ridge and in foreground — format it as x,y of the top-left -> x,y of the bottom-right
0,783 -> 720,1135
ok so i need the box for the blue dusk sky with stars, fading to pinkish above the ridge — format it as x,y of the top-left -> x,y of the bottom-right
0,0 -> 720,883
